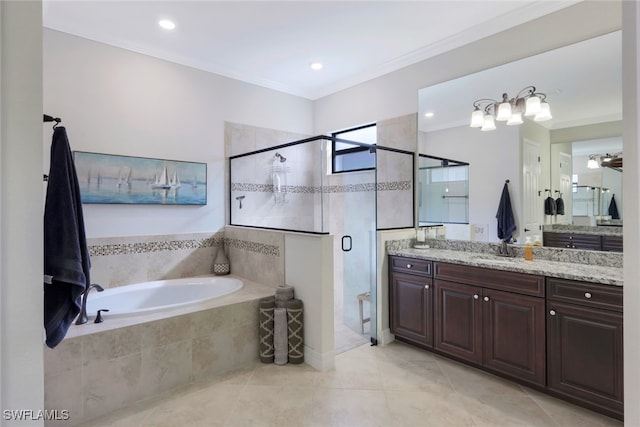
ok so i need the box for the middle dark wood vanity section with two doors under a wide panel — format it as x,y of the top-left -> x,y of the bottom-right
434,262 -> 546,386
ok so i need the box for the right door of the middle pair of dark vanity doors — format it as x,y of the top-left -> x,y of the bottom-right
482,289 -> 546,386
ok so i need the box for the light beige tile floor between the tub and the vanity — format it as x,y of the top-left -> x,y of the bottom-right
77,342 -> 622,427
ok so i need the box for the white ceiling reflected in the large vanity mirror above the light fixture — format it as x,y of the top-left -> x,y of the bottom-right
419,31 -> 622,131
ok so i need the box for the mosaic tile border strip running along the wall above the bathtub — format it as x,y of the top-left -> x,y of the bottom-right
88,237 -> 280,257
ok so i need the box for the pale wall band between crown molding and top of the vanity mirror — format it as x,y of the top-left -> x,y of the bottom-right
314,1 -> 620,134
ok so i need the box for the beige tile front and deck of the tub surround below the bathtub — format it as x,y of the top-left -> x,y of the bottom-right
44,280 -> 273,426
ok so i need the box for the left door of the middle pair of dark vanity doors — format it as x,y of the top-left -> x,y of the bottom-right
434,280 -> 482,364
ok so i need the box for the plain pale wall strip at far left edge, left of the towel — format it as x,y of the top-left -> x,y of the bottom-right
0,1 -> 44,426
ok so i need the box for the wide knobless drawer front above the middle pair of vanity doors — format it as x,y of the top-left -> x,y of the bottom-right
433,262 -> 544,297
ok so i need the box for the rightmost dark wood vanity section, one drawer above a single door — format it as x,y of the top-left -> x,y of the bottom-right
547,278 -> 623,419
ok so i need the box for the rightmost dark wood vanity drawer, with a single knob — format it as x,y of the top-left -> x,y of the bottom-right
547,277 -> 622,312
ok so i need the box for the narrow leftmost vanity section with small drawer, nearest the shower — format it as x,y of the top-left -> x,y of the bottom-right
389,257 -> 433,348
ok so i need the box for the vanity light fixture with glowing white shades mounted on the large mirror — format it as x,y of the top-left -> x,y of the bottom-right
470,86 -> 553,131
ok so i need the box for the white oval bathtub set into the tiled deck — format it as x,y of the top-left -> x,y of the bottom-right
87,276 -> 243,317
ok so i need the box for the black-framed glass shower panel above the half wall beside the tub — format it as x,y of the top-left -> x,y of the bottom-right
229,136 -> 331,234
